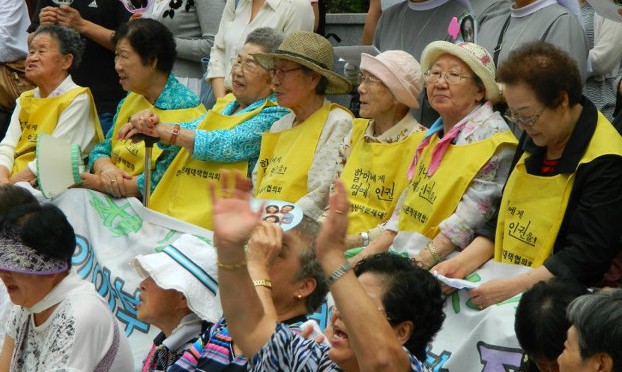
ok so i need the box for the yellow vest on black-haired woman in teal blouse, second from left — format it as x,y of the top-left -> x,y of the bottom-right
111,92 -> 205,176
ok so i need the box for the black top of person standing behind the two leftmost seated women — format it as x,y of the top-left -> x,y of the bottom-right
28,0 -> 131,114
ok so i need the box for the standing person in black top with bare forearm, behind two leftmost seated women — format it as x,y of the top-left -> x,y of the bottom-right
29,0 -> 130,133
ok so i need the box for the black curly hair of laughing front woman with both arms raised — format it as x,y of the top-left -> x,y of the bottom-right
354,253 -> 445,360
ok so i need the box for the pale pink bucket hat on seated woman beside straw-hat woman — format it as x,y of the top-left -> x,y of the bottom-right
361,50 -> 423,108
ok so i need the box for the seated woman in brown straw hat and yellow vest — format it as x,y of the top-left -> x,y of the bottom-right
253,31 -> 352,218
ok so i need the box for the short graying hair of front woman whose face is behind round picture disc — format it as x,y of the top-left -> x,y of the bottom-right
291,215 -> 328,313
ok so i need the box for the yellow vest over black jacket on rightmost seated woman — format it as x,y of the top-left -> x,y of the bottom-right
494,113 -> 622,268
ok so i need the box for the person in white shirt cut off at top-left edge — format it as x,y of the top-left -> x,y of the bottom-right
0,0 -> 30,140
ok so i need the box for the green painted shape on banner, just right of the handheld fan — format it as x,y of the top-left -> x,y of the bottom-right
89,191 -> 143,237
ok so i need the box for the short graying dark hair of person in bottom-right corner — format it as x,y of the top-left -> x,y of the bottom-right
567,288 -> 622,371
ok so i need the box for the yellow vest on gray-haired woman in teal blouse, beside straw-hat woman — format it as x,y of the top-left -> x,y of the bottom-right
149,94 -> 276,230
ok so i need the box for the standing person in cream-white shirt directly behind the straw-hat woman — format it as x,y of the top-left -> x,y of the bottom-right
206,0 -> 314,104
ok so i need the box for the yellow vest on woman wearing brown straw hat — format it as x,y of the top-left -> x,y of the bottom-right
255,103 -> 347,203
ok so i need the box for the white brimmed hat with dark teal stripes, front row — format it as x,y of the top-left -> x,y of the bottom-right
130,234 -> 222,322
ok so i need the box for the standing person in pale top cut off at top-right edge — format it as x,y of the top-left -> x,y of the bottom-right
579,0 -> 622,121
